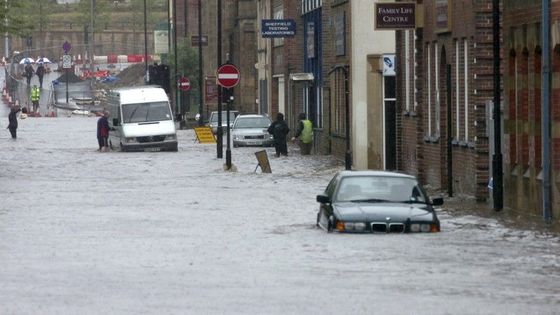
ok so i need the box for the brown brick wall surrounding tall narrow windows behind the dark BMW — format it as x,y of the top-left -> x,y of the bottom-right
397,0 -> 493,200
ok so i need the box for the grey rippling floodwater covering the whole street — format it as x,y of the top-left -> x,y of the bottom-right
0,115 -> 560,314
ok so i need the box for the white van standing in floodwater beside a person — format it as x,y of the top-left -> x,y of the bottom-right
107,86 -> 177,151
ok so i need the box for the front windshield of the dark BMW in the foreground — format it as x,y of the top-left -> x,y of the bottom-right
334,176 -> 427,203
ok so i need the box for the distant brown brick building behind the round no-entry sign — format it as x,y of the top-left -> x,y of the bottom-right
176,0 -> 258,117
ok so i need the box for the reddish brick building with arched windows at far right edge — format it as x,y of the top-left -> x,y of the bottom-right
503,0 -> 560,221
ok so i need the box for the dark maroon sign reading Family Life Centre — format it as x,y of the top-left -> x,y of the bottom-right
375,2 -> 416,30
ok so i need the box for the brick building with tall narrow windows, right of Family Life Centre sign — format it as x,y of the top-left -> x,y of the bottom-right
396,0 -> 493,201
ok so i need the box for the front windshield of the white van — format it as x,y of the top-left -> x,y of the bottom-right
122,102 -> 172,123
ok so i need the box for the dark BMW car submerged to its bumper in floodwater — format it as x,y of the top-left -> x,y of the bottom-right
317,171 -> 443,233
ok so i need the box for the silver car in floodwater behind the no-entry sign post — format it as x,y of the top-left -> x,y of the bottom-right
231,115 -> 274,148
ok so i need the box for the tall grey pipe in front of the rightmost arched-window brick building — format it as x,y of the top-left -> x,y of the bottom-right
541,0 -> 552,223
